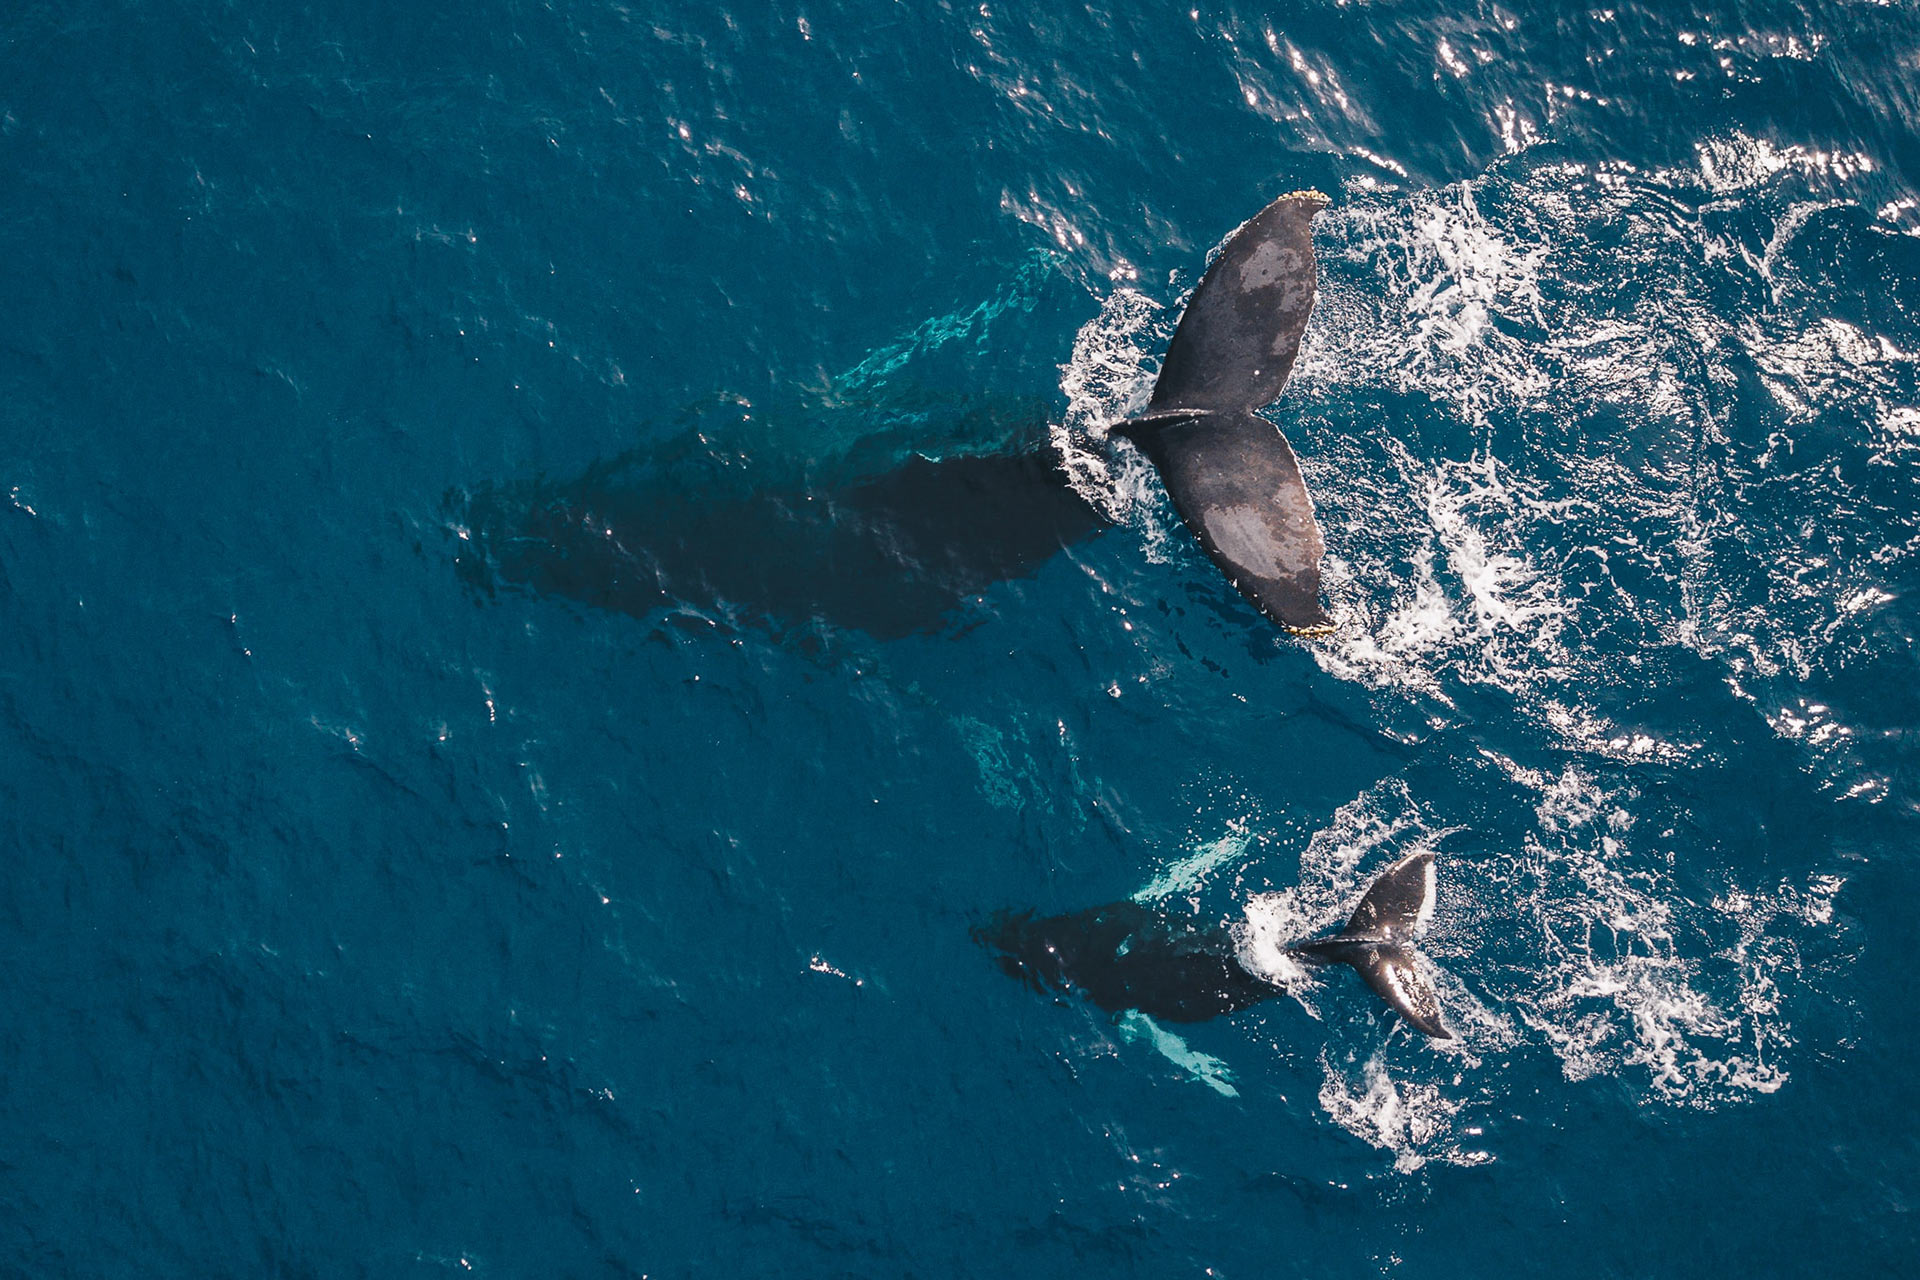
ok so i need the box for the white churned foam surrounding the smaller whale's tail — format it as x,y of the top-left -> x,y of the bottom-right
1223,775 -> 1841,1171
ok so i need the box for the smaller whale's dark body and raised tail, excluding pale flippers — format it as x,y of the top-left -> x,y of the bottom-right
973,850 -> 1453,1040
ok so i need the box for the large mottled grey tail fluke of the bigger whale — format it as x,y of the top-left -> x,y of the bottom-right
1116,192 -> 1332,635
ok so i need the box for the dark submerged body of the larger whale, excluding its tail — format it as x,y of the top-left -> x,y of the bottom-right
447,395 -> 1108,639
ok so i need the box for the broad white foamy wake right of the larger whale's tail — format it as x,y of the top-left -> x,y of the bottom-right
1277,150 -> 1920,798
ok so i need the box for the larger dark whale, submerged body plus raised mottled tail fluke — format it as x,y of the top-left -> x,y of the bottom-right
447,192 -> 1331,639
